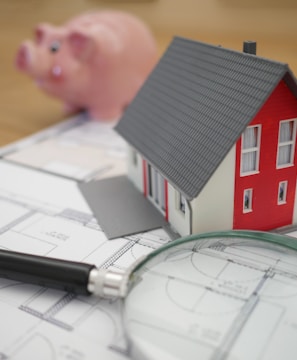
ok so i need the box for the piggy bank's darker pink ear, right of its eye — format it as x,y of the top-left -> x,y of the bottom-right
68,31 -> 95,61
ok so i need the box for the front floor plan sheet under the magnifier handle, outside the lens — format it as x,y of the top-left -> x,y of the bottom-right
0,161 -> 170,360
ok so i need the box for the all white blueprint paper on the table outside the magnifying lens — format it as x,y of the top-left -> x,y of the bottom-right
0,116 -> 170,360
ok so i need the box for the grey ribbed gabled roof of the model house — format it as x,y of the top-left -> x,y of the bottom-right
116,38 -> 297,199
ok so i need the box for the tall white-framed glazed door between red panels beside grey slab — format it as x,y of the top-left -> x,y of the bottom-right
147,164 -> 166,212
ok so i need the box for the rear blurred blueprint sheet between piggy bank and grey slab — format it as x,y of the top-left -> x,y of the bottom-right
0,114 -> 126,181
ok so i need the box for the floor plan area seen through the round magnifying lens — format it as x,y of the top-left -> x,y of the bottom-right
126,236 -> 297,360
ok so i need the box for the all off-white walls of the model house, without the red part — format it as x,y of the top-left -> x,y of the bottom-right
127,146 -> 235,236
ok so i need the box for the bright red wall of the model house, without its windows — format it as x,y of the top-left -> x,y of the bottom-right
233,81 -> 297,230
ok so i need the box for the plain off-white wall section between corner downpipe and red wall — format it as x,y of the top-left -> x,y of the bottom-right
191,146 -> 235,233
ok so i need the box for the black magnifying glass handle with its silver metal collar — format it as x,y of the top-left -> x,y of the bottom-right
0,250 -> 126,298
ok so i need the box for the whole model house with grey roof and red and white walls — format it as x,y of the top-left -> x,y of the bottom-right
116,38 -> 297,235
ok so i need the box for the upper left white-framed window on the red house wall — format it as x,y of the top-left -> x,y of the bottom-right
241,126 -> 260,175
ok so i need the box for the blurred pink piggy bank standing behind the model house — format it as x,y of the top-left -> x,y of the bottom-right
16,11 -> 157,120
